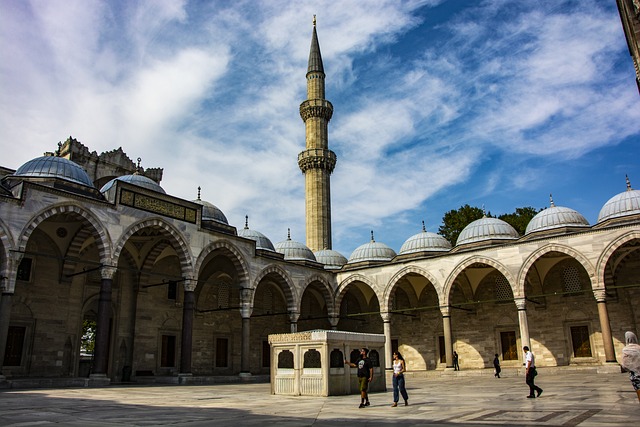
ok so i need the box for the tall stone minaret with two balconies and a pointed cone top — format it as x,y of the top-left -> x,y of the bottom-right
298,15 -> 336,252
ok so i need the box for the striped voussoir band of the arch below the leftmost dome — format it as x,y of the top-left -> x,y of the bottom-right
17,203 -> 112,265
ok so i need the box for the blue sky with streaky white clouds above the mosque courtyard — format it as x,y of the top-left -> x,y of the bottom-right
0,0 -> 640,257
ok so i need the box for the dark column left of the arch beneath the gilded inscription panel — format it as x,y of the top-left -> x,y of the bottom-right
91,266 -> 117,377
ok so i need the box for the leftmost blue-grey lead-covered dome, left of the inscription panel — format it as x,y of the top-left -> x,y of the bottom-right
13,156 -> 94,187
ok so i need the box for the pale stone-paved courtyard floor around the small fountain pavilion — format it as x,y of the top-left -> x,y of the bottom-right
0,370 -> 640,427
